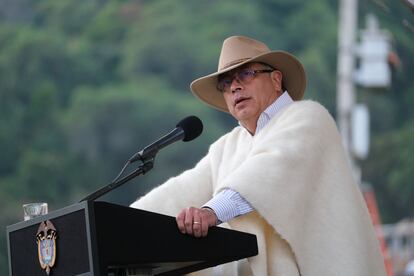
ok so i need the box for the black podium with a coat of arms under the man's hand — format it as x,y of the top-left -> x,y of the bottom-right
7,201 -> 258,276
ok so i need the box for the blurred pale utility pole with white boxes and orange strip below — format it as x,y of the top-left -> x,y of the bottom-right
336,0 -> 396,276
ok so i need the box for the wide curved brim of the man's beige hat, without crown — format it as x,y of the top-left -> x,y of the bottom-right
190,51 -> 306,112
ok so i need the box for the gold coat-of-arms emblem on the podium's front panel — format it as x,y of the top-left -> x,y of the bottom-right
36,220 -> 57,275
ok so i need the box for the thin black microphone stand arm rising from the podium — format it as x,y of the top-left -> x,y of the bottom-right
79,157 -> 155,202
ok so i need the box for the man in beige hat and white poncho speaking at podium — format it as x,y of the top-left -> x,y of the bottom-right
132,36 -> 385,276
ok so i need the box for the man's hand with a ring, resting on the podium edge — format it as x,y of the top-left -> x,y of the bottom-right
176,207 -> 217,238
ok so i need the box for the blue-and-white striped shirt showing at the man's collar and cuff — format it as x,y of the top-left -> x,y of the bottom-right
203,91 -> 293,223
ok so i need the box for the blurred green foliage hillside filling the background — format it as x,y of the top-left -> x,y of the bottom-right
0,0 -> 414,275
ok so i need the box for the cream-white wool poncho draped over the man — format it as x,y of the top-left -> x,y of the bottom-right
131,101 -> 385,276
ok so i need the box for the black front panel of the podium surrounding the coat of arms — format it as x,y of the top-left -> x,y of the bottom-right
8,209 -> 90,276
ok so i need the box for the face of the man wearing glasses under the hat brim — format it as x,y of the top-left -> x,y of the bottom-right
220,63 -> 282,131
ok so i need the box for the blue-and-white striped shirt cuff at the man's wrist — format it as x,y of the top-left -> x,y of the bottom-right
203,189 -> 254,223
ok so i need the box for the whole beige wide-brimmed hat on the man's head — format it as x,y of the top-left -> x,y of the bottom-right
190,36 -> 306,112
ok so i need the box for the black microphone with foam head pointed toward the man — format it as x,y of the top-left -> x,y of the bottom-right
129,116 -> 203,163
